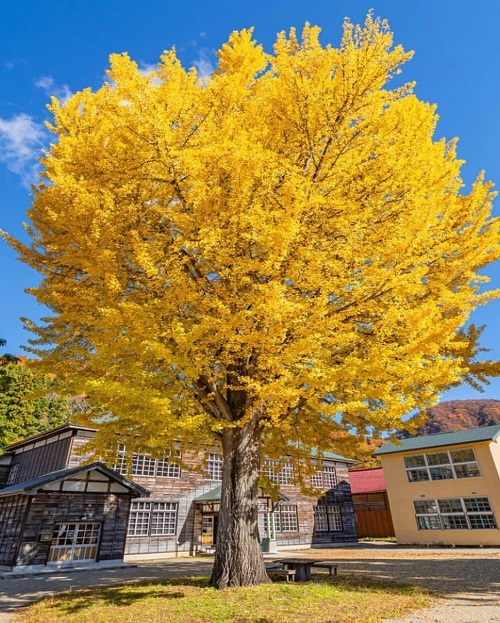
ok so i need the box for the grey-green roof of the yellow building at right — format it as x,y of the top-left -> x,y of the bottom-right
374,424 -> 500,456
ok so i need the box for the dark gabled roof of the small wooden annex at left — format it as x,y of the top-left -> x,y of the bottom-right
0,461 -> 149,497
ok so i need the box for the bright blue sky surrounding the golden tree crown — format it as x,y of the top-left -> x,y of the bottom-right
0,0 -> 500,399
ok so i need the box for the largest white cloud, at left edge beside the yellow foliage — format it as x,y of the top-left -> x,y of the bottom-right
0,113 -> 48,187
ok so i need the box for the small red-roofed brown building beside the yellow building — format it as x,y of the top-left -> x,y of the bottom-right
349,467 -> 395,538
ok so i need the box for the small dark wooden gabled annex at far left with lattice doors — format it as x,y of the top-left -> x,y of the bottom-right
0,460 -> 147,570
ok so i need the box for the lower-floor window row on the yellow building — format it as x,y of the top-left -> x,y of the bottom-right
413,497 -> 497,530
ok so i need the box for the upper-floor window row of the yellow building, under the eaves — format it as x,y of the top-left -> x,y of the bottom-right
404,448 -> 481,482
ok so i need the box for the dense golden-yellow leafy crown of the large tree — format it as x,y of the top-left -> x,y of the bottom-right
6,16 -> 499,446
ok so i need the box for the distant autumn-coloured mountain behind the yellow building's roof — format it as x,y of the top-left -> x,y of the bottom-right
399,399 -> 500,439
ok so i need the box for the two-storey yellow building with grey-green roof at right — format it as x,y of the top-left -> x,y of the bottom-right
375,424 -> 500,547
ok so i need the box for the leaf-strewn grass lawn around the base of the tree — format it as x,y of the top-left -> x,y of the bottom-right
15,575 -> 430,623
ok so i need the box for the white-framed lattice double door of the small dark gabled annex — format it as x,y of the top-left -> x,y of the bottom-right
47,522 -> 101,563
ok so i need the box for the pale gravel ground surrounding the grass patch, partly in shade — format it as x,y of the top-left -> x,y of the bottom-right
0,543 -> 500,623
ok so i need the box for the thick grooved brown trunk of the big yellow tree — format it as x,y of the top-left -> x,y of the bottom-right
210,421 -> 269,588
